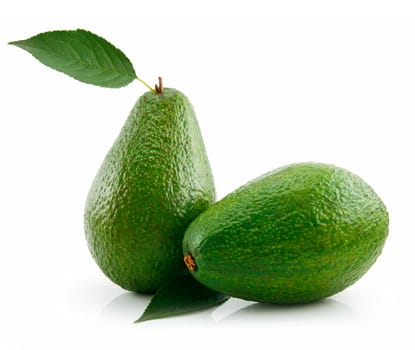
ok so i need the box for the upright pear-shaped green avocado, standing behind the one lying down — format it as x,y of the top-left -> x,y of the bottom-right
84,88 -> 215,293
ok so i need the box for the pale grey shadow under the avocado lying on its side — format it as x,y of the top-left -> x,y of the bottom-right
221,298 -> 361,322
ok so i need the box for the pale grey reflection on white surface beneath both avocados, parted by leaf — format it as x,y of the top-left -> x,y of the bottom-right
98,292 -> 363,326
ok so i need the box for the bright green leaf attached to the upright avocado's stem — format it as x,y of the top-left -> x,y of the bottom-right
9,29 -> 136,88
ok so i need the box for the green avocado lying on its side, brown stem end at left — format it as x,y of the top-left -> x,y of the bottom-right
183,163 -> 389,304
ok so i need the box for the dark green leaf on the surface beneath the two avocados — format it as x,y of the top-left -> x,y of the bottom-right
135,271 -> 229,323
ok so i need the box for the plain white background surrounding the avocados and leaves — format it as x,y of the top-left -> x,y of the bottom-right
0,1 -> 415,349
